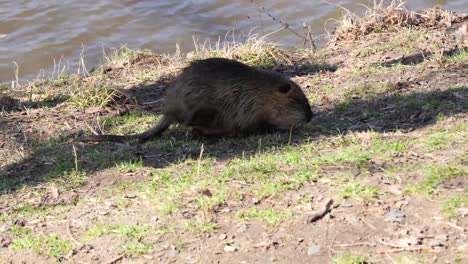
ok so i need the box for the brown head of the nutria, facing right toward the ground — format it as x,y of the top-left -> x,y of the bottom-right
267,80 -> 312,129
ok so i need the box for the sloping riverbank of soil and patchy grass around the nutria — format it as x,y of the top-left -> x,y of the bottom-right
0,6 -> 468,263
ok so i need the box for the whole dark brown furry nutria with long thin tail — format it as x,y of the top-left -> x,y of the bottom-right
81,58 -> 312,143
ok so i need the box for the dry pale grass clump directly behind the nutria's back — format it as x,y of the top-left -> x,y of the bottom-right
189,29 -> 289,67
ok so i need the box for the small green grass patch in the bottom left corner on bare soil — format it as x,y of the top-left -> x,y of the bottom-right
11,228 -> 73,261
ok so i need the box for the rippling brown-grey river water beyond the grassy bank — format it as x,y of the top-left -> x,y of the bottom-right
0,0 -> 468,83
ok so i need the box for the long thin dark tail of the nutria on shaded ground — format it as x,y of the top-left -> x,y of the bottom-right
76,116 -> 174,143
